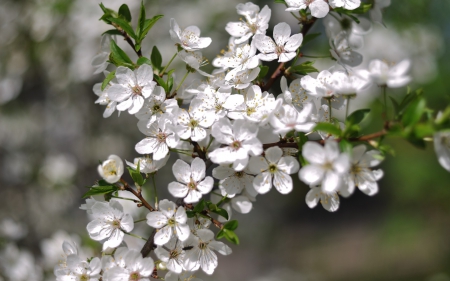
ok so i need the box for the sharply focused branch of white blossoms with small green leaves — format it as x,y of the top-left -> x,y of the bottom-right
55,0 -> 450,281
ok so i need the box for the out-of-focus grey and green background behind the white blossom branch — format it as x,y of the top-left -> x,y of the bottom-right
0,0 -> 450,281
